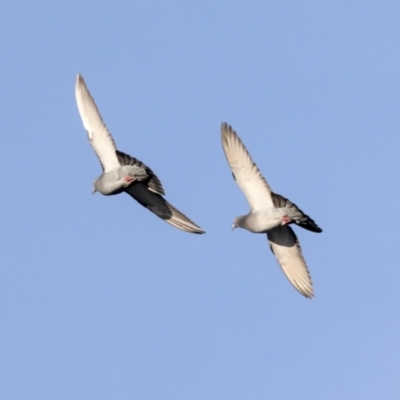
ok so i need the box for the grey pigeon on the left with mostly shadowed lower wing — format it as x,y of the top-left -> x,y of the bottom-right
75,75 -> 204,233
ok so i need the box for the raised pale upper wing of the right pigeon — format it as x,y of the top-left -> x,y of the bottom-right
221,123 -> 274,210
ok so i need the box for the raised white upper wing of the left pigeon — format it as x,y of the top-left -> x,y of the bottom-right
75,75 -> 120,172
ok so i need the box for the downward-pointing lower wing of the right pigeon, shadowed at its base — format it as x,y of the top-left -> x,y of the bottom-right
267,225 -> 314,298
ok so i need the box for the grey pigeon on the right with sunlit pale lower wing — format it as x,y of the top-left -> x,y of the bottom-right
221,123 -> 322,298
